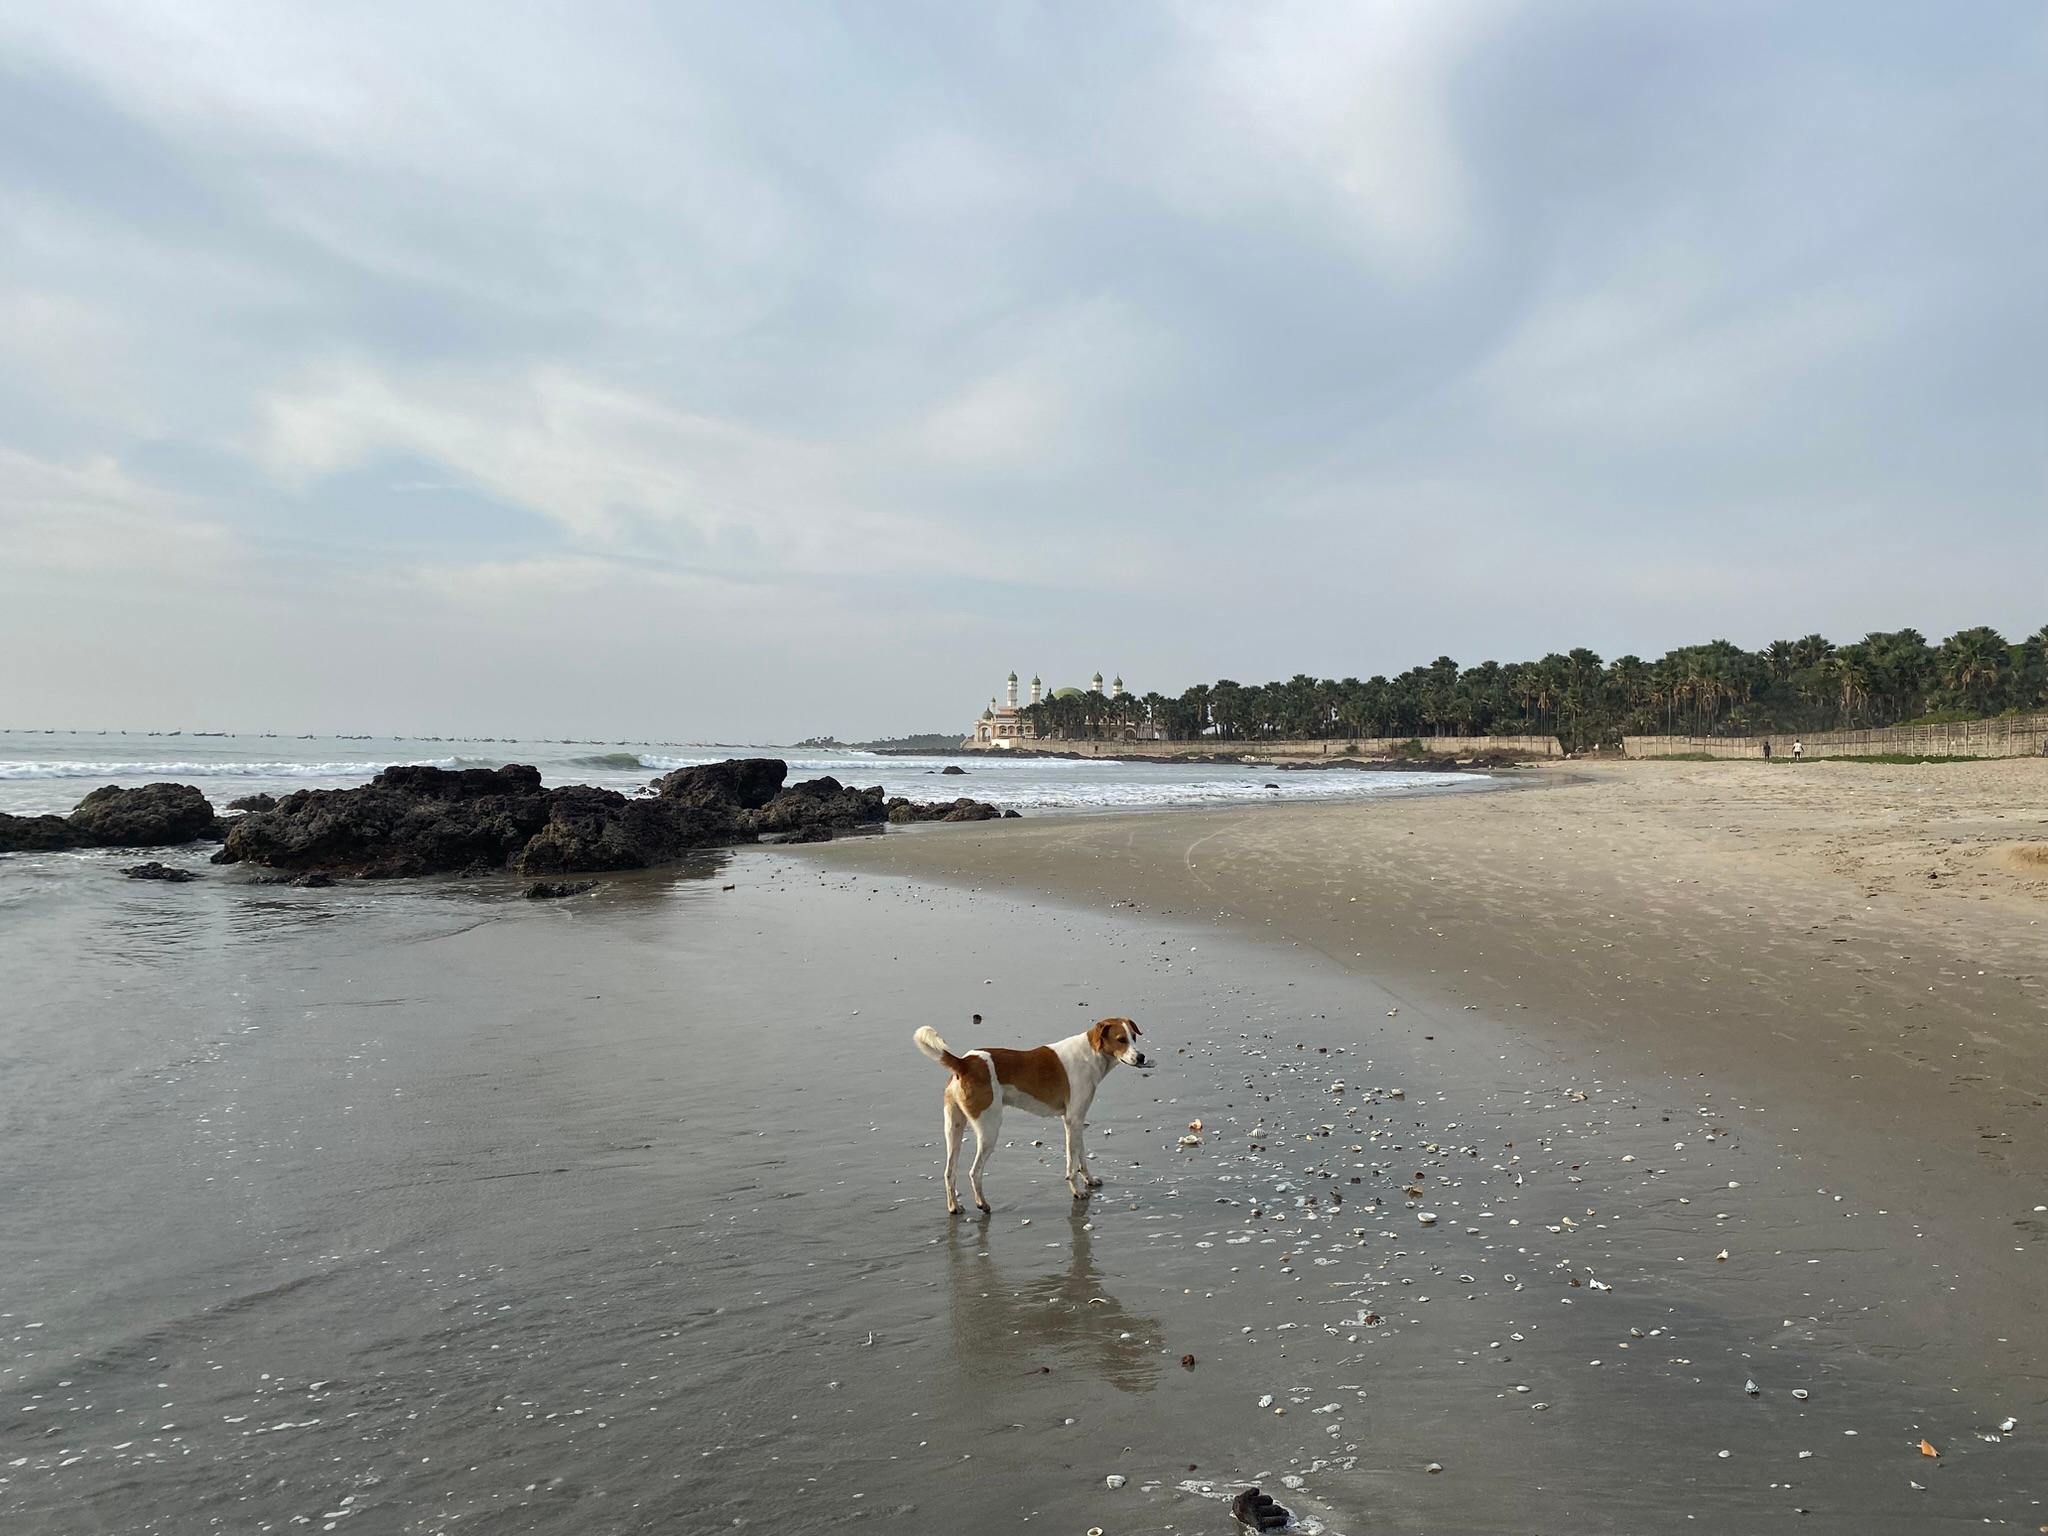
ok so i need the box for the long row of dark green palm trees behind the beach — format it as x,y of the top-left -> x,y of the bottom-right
1024,625 -> 2048,750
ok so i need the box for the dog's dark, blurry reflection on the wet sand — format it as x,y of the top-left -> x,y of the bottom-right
946,1206 -> 1163,1393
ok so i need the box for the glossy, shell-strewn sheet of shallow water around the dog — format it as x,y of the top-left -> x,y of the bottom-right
0,852 -> 2048,1536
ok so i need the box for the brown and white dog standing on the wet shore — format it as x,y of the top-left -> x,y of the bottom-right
913,1014 -> 1151,1214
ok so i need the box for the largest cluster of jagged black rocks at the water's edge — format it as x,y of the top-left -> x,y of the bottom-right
199,758 -> 1016,879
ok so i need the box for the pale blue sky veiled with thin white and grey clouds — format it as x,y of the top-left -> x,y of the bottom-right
0,0 -> 2048,739
